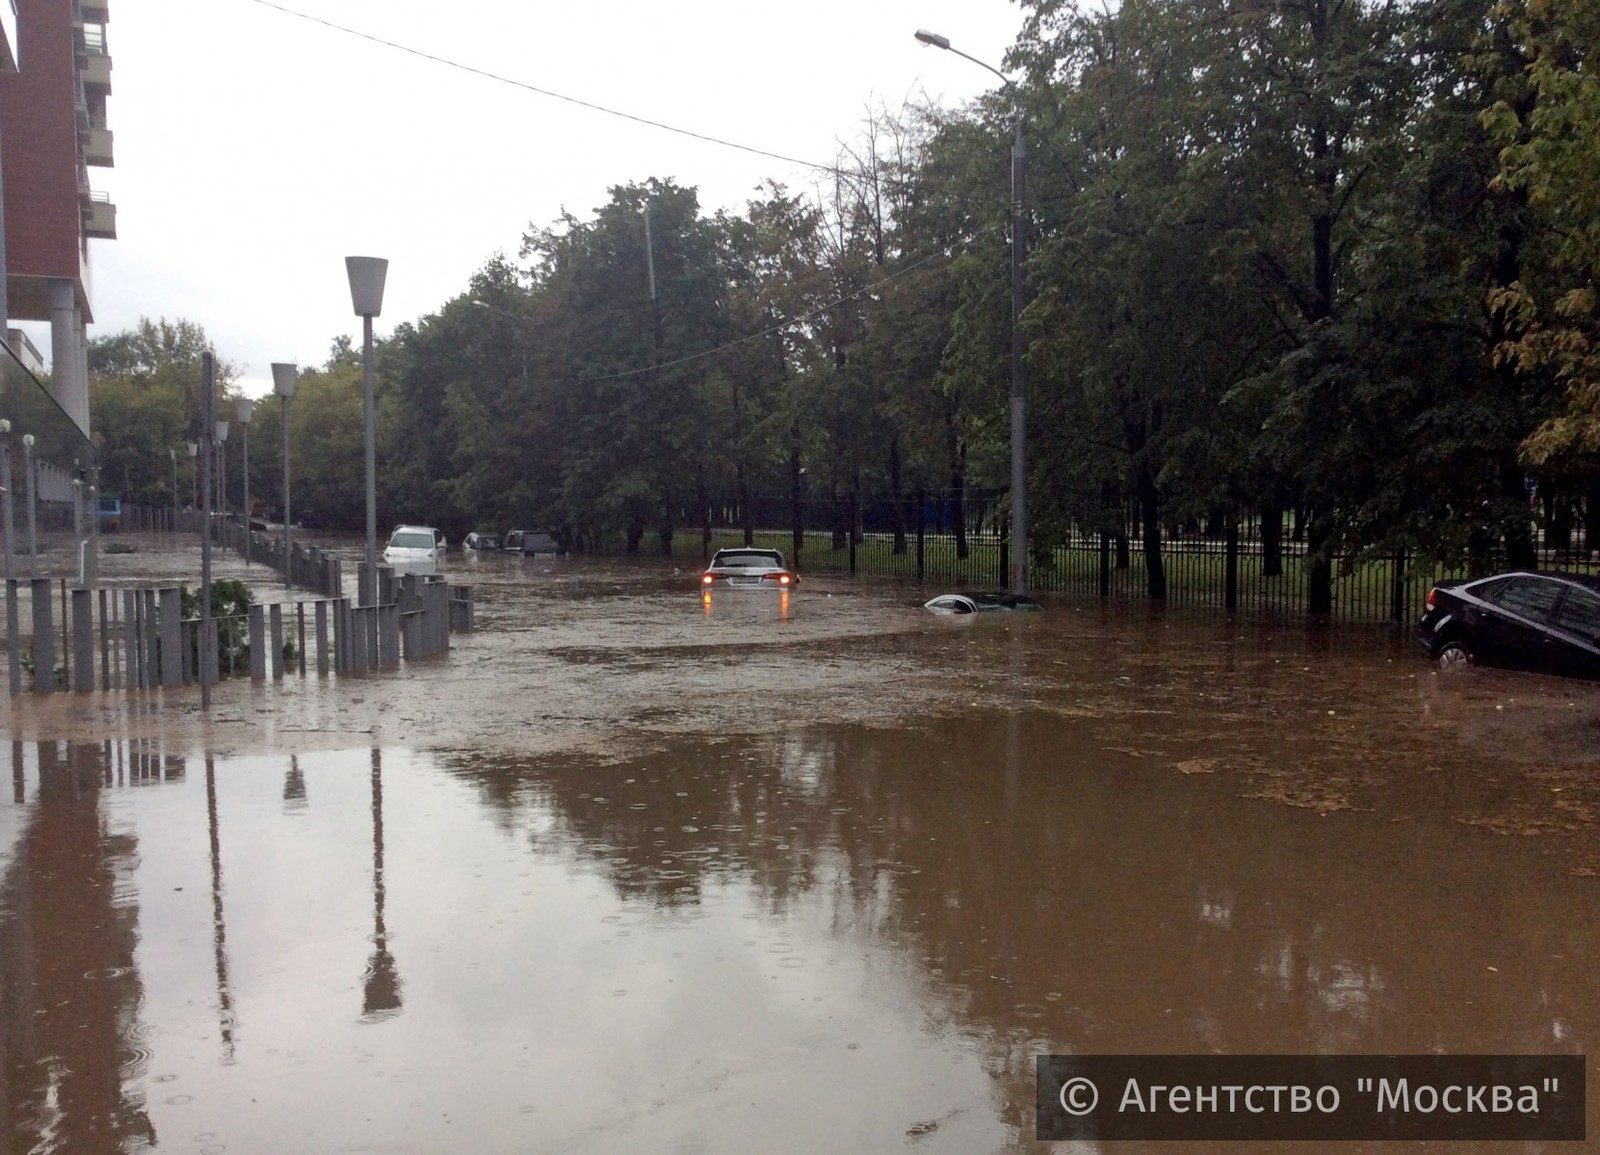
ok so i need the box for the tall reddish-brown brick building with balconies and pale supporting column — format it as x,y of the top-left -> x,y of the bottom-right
0,0 -> 117,435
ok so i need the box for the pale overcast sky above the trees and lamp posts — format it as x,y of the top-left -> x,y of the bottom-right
24,0 -> 1022,395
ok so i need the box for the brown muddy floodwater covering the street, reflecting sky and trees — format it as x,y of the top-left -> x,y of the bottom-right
0,543 -> 1600,1155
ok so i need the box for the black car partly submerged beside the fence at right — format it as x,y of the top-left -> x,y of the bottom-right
1416,573 -> 1600,678
